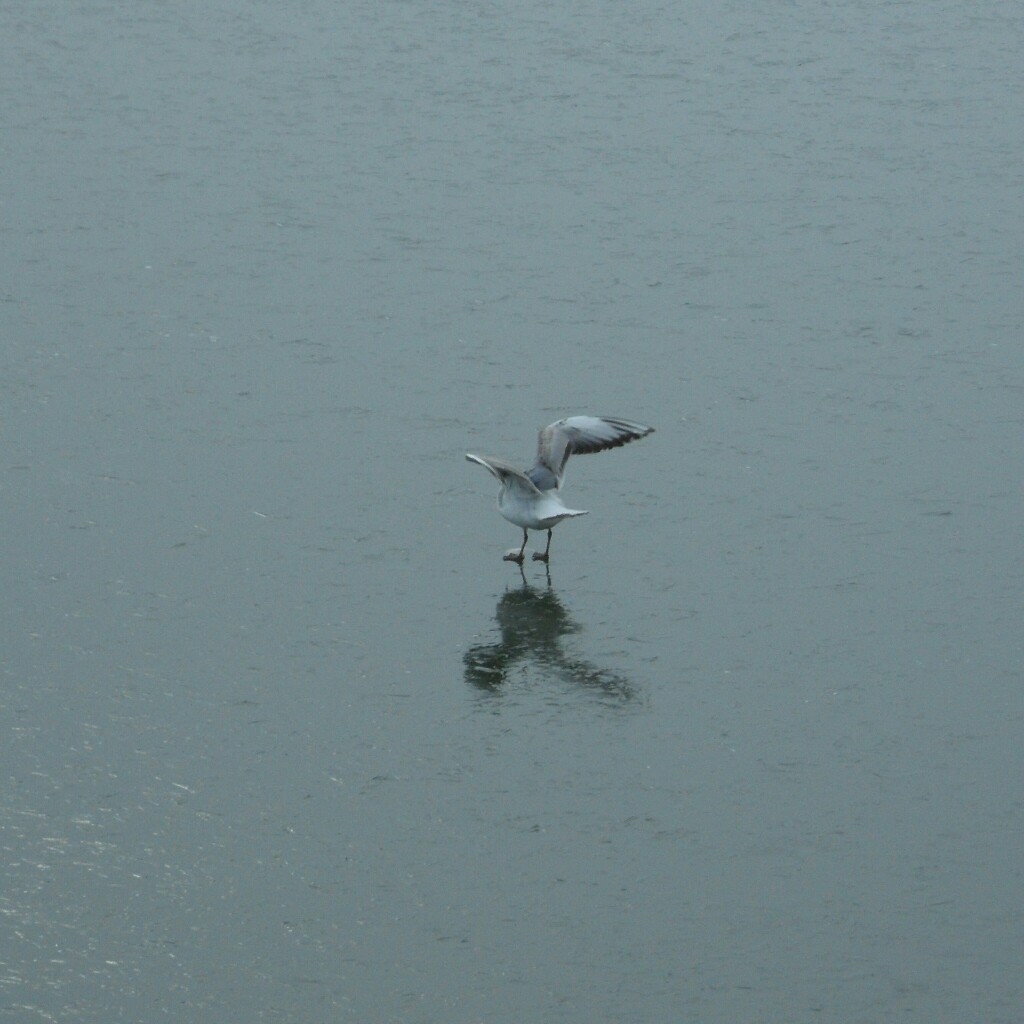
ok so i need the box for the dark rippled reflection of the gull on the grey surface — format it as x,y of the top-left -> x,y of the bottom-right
463,581 -> 636,701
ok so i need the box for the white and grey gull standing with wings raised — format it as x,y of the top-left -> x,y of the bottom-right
466,416 -> 654,566
